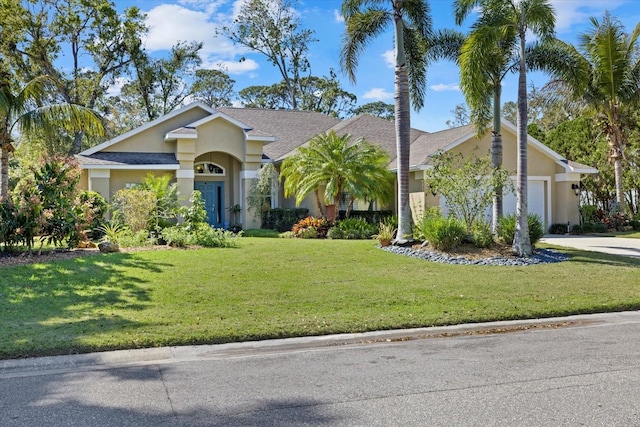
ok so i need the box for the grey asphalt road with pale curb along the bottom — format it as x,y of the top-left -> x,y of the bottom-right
0,312 -> 640,427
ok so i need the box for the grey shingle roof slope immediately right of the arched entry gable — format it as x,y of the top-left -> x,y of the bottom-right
217,107 -> 340,160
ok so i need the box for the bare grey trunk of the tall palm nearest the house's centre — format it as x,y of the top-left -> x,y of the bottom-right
394,18 -> 413,244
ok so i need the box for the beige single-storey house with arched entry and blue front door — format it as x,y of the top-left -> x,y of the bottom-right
77,102 -> 597,228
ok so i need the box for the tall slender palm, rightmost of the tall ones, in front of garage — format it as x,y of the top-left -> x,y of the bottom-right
455,0 -> 555,256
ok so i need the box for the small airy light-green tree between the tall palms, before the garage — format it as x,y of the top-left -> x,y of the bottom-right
427,153 -> 513,230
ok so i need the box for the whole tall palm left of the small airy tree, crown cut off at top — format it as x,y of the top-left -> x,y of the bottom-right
340,0 -> 431,243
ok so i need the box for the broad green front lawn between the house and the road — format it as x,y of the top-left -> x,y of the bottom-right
0,238 -> 640,358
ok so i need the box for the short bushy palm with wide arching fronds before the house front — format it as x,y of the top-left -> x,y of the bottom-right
280,130 -> 393,215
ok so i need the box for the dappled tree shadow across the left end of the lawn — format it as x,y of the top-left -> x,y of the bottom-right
0,253 -> 172,358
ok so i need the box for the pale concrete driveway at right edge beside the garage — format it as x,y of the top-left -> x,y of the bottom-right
540,234 -> 640,258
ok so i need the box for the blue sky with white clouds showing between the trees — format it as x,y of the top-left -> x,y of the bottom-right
116,0 -> 640,132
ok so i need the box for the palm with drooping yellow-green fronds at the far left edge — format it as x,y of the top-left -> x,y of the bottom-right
0,68 -> 104,199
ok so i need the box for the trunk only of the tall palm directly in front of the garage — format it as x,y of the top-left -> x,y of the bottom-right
513,35 -> 533,257
